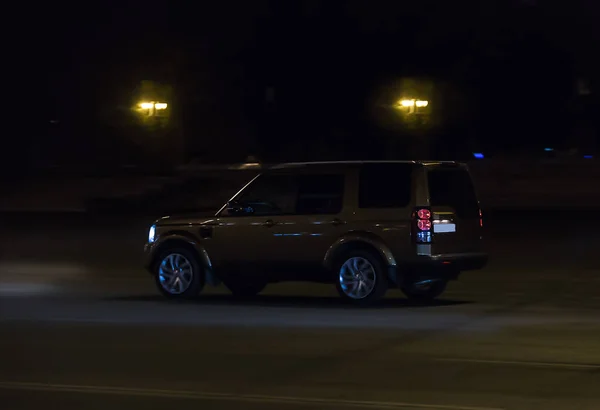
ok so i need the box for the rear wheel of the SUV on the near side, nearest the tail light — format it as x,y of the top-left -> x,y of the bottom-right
335,250 -> 389,306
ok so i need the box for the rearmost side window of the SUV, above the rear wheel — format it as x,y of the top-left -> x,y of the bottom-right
358,163 -> 413,208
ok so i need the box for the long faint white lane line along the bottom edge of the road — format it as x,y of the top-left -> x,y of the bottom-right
0,382 -> 504,410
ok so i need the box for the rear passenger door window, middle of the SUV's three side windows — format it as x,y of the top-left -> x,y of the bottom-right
296,175 -> 344,215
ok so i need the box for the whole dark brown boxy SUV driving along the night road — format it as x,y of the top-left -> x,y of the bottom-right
145,161 -> 487,304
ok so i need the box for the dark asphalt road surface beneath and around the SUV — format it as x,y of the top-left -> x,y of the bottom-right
0,213 -> 600,410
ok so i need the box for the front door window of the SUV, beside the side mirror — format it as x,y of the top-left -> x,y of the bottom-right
236,174 -> 298,215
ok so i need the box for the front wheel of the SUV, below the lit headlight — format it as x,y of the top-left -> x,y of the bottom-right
154,247 -> 206,300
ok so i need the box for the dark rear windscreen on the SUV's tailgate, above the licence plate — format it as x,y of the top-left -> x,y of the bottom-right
427,168 -> 479,218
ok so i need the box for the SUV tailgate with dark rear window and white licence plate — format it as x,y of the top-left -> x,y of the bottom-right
426,164 -> 482,254
